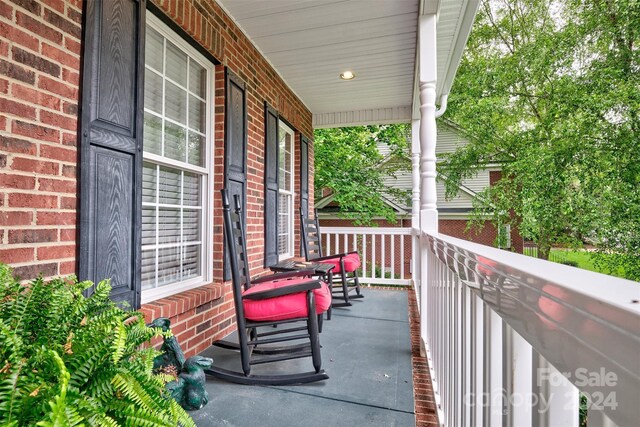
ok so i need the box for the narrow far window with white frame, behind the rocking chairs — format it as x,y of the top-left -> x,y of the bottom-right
278,122 -> 295,259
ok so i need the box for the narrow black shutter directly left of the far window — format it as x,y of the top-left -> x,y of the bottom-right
264,103 -> 279,267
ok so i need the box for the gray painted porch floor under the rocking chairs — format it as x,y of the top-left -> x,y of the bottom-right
191,288 -> 415,427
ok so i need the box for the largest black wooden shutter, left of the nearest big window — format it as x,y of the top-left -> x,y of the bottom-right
78,0 -> 145,308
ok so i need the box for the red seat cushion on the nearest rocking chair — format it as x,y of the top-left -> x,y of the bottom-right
242,278 -> 331,321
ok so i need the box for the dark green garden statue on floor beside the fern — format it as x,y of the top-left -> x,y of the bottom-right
149,317 -> 213,410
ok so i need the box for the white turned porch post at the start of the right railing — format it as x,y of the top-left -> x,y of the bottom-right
419,13 -> 438,352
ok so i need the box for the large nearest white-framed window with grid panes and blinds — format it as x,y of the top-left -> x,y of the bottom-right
142,16 -> 213,303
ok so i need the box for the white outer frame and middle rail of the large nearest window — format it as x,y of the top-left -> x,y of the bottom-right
141,14 -> 215,304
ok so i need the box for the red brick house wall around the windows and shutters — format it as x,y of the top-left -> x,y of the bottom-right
0,0 -> 313,356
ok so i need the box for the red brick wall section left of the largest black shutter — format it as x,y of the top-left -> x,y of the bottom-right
0,0 -> 82,278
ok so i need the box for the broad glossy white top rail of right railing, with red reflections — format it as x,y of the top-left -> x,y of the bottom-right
423,233 -> 640,425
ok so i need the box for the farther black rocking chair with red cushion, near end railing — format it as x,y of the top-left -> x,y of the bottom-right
300,209 -> 364,313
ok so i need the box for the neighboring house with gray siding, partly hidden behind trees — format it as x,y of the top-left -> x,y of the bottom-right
315,119 -> 522,253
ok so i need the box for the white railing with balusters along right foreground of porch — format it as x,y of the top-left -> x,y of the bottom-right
420,233 -> 640,427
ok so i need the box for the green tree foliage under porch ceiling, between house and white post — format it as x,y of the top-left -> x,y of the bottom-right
314,124 -> 411,225
